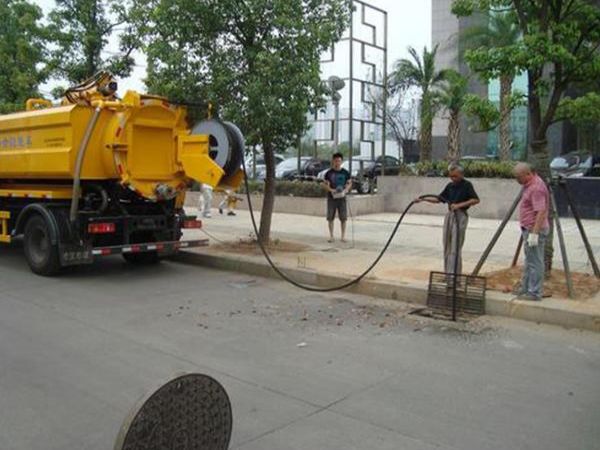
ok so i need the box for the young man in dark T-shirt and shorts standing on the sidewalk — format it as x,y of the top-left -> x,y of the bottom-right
324,153 -> 352,242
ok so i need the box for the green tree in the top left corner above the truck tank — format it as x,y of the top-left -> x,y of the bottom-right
0,0 -> 48,113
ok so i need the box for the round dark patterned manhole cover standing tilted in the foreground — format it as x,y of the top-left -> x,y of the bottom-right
115,374 -> 232,450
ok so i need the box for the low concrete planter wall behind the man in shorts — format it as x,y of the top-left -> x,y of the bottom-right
185,192 -> 385,217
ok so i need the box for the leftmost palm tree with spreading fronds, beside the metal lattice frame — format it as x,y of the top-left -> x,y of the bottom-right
392,45 -> 446,161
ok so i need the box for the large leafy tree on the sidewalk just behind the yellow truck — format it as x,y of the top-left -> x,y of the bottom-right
131,0 -> 350,243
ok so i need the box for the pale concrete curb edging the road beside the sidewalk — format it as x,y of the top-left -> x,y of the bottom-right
170,250 -> 600,332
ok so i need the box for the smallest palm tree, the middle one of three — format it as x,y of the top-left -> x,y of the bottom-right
436,69 -> 468,162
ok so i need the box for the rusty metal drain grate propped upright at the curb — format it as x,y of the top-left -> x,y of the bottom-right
427,272 -> 487,316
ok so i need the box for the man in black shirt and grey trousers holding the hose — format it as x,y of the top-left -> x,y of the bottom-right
417,164 -> 479,274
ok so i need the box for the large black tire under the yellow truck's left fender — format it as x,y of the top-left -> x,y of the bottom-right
23,214 -> 61,276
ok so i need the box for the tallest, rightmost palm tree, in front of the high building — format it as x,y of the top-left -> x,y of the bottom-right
460,11 -> 521,161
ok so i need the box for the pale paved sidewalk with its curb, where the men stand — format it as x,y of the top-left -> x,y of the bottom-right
186,207 -> 600,331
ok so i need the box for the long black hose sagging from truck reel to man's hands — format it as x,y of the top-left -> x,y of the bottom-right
242,158 -> 439,292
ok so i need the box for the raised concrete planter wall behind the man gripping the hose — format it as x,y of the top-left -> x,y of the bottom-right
378,176 -> 521,219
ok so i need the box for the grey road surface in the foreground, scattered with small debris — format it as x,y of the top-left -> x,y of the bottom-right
0,248 -> 600,450
